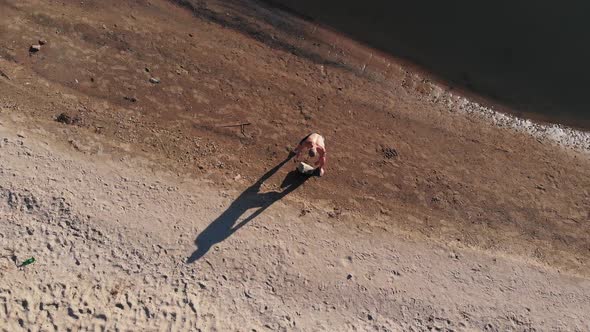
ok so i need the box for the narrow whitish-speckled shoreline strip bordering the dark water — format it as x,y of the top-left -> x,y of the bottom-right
261,0 -> 590,147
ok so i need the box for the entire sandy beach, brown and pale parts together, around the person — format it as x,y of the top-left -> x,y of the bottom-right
0,0 -> 590,331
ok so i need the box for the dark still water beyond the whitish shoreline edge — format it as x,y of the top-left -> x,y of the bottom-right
265,0 -> 590,129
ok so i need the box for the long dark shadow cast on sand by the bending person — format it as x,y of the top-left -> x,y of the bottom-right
187,154 -> 317,263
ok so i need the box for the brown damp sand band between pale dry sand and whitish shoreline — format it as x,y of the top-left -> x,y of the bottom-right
0,0 -> 590,328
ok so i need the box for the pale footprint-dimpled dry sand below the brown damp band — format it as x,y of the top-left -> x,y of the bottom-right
0,115 -> 590,331
